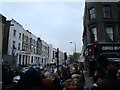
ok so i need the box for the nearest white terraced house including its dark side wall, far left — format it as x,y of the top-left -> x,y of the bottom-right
2,19 -> 23,68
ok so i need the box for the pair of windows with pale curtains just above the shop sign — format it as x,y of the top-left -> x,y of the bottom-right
91,27 -> 114,42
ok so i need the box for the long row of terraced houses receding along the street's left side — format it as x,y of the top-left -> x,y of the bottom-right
0,14 -> 64,68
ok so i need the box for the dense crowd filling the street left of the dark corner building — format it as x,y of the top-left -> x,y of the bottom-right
16,63 -> 85,90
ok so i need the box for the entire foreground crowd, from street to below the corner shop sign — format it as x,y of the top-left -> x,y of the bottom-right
9,63 -> 120,90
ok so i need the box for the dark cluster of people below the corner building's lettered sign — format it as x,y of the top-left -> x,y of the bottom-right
91,65 -> 120,90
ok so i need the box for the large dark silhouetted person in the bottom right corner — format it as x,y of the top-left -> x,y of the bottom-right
97,66 -> 120,90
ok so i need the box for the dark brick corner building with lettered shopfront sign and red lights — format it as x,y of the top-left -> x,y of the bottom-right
83,2 -> 120,76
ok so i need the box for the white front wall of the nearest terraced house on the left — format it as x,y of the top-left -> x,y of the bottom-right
8,19 -> 24,59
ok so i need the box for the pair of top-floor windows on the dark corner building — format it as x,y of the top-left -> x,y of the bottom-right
89,5 -> 112,20
